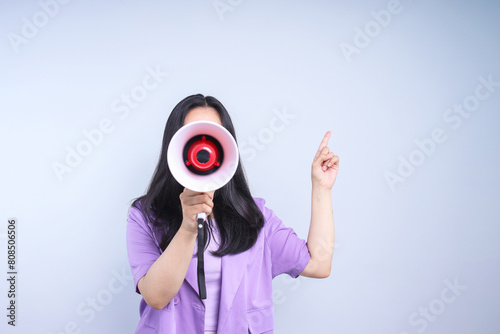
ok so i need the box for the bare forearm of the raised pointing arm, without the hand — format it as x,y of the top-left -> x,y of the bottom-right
307,186 -> 335,278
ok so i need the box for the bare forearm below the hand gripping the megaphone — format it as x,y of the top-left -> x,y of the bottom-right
138,227 -> 197,310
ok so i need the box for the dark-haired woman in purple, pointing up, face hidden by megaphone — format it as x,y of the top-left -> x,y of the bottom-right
127,94 -> 339,334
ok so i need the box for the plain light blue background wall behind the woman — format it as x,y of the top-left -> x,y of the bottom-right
0,0 -> 500,334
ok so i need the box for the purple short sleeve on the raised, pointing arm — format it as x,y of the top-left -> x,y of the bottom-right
255,198 -> 311,278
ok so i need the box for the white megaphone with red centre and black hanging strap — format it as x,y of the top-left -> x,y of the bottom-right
167,121 -> 239,299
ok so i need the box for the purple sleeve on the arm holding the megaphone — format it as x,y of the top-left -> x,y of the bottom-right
127,207 -> 161,293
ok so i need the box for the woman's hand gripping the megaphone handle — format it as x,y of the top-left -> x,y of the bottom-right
179,188 -> 215,234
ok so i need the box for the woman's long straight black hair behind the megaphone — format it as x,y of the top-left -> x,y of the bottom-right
132,94 -> 264,256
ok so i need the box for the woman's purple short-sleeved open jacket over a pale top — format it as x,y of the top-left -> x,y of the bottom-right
127,198 -> 311,334
